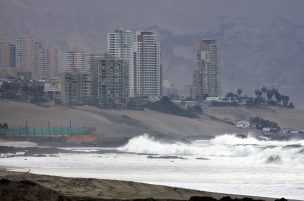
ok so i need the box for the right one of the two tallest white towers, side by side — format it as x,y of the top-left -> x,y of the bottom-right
134,31 -> 162,101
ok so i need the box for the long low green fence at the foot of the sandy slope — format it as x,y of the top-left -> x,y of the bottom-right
0,127 -> 90,136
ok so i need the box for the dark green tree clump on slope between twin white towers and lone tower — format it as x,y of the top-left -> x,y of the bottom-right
146,96 -> 203,118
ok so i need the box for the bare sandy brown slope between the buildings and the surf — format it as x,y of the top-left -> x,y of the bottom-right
0,101 -> 304,144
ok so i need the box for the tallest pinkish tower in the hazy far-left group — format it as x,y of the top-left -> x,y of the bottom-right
16,34 -> 36,75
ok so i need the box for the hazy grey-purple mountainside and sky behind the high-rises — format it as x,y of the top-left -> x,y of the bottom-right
0,0 -> 304,105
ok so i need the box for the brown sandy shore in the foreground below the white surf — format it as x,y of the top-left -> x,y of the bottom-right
0,170 -> 288,201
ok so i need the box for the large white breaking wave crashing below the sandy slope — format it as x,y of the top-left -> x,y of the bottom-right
118,134 -> 304,163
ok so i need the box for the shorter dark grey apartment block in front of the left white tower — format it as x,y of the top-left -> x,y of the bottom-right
91,54 -> 129,108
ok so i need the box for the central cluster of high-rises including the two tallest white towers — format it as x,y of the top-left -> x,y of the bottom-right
62,29 -> 162,108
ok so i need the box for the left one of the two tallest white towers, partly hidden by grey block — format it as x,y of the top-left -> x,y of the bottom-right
108,28 -> 135,97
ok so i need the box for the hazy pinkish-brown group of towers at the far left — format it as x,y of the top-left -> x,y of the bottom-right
0,34 -> 59,80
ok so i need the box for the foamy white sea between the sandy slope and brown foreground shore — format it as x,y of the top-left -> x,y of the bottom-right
0,134 -> 304,200
